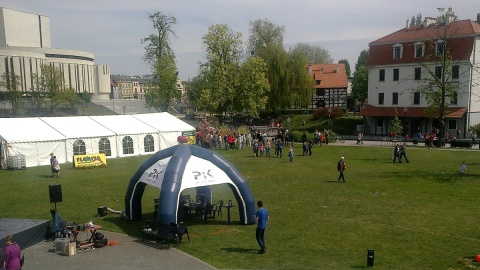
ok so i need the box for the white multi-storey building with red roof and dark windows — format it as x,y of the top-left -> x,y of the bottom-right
359,13 -> 480,138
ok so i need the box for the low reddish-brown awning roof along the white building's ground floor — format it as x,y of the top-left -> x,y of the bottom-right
358,105 -> 467,118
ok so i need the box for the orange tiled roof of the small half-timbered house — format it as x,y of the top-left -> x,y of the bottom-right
308,64 -> 348,89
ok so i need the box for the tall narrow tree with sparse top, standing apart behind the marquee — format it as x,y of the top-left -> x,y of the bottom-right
142,12 -> 181,111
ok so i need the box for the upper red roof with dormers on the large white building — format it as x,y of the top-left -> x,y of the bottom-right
367,20 -> 480,66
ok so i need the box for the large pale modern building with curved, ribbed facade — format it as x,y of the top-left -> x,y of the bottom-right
0,7 -> 111,100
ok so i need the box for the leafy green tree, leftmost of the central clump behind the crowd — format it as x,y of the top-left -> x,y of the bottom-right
199,24 -> 242,123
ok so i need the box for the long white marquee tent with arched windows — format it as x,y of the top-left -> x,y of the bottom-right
0,113 -> 195,167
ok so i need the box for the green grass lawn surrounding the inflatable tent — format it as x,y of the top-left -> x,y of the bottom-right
0,144 -> 480,269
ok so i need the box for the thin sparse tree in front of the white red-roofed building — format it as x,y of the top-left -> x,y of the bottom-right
411,8 -> 478,141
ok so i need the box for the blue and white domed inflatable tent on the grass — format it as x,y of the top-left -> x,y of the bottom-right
125,145 -> 255,224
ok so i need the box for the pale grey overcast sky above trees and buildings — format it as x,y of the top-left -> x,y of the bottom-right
0,0 -> 480,80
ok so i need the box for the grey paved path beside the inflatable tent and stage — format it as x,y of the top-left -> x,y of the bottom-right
22,231 -> 216,270
